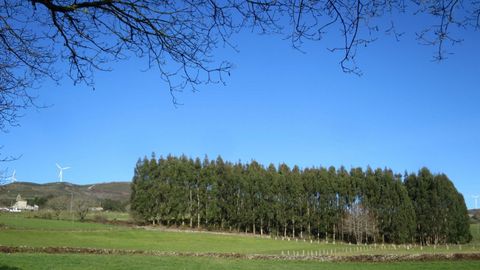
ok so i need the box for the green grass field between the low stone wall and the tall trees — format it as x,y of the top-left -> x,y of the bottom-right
0,214 -> 480,255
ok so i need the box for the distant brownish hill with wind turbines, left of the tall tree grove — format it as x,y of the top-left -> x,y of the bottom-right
0,182 -> 130,205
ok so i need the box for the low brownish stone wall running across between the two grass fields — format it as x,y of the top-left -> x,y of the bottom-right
0,246 -> 480,262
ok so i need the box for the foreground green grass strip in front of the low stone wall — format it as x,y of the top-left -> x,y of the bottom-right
0,254 -> 480,270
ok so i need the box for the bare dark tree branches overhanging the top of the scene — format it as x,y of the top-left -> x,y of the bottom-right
0,0 -> 480,143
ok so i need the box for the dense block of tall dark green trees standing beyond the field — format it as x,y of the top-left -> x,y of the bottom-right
131,154 -> 471,245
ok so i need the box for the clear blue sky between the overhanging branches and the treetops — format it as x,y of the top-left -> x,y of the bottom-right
0,18 -> 480,207
